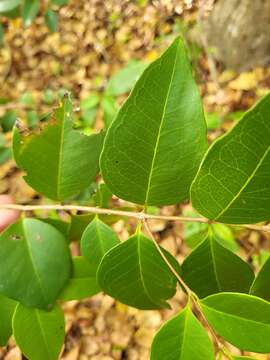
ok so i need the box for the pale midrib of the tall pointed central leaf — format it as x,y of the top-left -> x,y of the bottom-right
145,42 -> 179,205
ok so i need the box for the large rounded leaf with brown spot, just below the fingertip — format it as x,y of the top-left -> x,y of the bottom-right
0,218 -> 71,309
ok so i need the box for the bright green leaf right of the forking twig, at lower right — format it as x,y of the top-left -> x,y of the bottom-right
201,293 -> 270,353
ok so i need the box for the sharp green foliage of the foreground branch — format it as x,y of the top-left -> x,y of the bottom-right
0,38 -> 270,360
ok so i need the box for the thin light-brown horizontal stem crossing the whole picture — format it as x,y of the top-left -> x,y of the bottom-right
0,204 -> 270,233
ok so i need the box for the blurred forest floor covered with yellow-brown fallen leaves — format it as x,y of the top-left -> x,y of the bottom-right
0,0 -> 270,360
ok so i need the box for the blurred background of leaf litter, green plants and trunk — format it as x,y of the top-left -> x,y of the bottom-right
0,0 -> 270,360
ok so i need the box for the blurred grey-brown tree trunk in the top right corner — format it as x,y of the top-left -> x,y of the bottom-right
204,0 -> 270,71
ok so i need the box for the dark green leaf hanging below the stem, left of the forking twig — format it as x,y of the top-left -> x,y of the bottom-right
97,233 -> 180,310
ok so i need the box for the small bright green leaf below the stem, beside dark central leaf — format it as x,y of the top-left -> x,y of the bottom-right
81,217 -> 120,271
